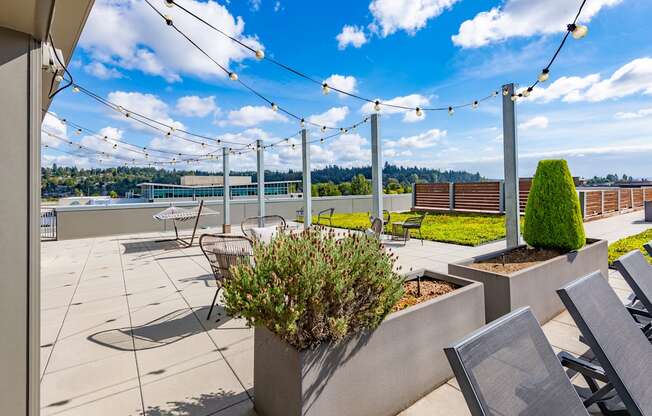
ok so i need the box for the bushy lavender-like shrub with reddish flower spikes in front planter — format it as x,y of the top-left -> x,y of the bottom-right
224,229 -> 403,350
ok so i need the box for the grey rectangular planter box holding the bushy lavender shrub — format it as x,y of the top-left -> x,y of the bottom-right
254,271 -> 484,416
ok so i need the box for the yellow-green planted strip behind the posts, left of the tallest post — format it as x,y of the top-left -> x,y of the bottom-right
306,212 -> 505,246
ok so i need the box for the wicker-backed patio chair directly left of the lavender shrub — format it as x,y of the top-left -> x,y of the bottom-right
199,234 -> 254,320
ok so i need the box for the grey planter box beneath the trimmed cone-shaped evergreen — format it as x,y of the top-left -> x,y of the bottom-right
448,239 -> 608,324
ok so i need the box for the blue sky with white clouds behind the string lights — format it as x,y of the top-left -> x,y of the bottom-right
43,0 -> 652,178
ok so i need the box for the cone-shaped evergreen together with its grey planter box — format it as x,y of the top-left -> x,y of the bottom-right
448,160 -> 608,324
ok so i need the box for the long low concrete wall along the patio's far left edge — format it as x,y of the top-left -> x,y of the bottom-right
54,194 -> 412,240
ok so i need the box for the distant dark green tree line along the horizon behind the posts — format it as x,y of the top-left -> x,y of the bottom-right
41,163 -> 484,198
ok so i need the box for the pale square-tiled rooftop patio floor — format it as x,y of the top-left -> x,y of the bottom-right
41,212 -> 647,416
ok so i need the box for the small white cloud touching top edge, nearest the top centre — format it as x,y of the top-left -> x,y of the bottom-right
369,0 -> 458,37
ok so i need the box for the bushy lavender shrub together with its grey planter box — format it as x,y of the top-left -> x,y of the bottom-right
224,229 -> 484,416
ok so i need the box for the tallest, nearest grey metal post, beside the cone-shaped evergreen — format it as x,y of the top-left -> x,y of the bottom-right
503,84 -> 521,248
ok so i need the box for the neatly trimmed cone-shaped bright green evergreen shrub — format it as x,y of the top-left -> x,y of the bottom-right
523,160 -> 586,251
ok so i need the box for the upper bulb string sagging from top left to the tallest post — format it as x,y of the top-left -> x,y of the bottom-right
164,0 -> 498,113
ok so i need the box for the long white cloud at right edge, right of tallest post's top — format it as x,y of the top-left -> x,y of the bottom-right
527,57 -> 652,102
